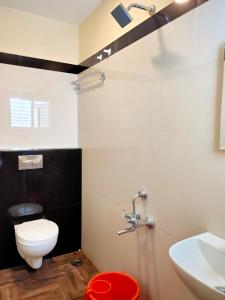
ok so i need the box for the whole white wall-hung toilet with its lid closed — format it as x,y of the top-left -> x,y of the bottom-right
14,219 -> 59,269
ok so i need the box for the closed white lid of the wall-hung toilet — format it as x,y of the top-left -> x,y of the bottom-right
16,219 -> 59,243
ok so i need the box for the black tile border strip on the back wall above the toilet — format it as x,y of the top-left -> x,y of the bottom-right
0,52 -> 87,74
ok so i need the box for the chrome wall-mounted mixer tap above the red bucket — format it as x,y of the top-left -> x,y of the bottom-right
117,189 -> 155,235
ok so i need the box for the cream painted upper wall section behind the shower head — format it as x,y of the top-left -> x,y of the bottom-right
79,0 -> 173,62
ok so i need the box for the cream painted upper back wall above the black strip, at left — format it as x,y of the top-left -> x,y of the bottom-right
0,6 -> 79,64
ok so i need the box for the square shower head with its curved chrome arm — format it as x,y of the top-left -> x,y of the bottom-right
111,3 -> 155,28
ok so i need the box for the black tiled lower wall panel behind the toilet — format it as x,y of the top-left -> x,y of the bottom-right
0,149 -> 82,268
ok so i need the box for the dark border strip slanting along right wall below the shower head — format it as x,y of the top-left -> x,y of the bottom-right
80,0 -> 210,68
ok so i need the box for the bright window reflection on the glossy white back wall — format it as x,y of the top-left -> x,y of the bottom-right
10,98 -> 49,128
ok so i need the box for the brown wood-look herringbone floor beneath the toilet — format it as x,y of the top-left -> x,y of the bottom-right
0,252 -> 97,300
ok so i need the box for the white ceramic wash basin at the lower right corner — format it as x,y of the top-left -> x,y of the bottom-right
169,232 -> 225,300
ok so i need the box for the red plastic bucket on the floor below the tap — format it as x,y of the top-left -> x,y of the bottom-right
84,272 -> 140,300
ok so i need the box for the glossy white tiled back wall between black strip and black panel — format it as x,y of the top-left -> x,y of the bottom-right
0,64 -> 78,149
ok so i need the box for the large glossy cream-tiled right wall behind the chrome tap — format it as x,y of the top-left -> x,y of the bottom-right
79,0 -> 225,300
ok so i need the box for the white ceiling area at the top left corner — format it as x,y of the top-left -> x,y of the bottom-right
0,0 -> 102,25
